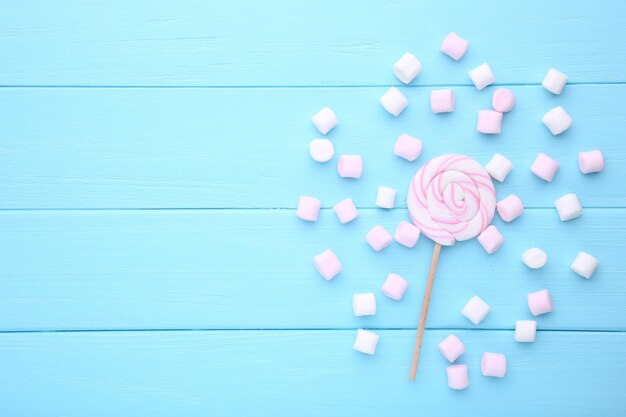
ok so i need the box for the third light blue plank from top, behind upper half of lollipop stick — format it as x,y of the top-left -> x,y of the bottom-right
0,209 -> 626,330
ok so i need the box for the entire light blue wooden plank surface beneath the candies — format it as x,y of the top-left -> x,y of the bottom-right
0,0 -> 626,416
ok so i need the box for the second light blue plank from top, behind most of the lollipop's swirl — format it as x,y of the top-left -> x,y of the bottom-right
0,85 -> 626,208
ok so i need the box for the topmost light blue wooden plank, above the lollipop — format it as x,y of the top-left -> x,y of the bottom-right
0,0 -> 626,86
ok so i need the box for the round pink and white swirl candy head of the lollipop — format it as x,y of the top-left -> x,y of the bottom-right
407,154 -> 496,246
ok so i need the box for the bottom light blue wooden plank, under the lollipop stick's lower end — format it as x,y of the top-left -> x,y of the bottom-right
0,330 -> 626,417
